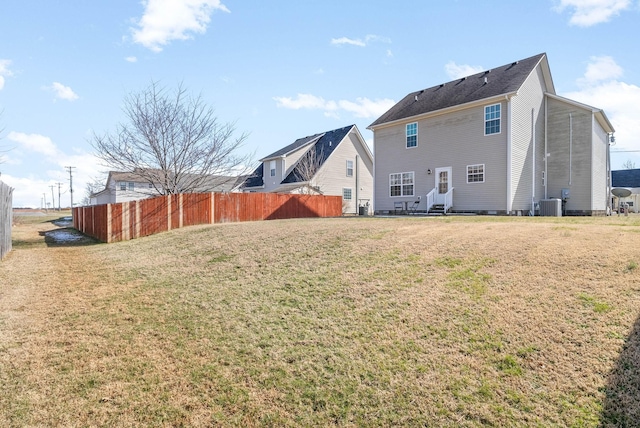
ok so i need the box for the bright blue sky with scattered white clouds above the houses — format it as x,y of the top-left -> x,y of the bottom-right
0,0 -> 640,207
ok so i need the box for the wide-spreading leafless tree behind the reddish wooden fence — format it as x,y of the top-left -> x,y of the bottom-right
92,82 -> 251,195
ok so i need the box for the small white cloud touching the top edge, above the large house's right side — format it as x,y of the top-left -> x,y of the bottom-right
555,0 -> 632,27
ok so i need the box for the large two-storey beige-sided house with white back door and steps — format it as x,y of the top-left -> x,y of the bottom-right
369,54 -> 614,215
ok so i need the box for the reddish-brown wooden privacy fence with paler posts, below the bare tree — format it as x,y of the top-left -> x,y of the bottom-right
73,193 -> 342,242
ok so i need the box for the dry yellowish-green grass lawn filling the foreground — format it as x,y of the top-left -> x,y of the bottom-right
0,212 -> 640,427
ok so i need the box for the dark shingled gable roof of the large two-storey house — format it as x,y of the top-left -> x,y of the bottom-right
369,53 -> 555,128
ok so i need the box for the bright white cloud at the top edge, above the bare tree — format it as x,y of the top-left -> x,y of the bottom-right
131,0 -> 229,52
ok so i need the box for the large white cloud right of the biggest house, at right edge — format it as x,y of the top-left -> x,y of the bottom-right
562,57 -> 640,157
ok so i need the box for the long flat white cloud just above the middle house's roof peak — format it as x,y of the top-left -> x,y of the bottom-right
273,94 -> 395,118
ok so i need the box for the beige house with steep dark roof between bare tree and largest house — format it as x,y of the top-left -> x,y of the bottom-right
243,125 -> 373,213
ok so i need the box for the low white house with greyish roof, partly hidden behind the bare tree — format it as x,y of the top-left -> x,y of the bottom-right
89,170 -> 245,205
